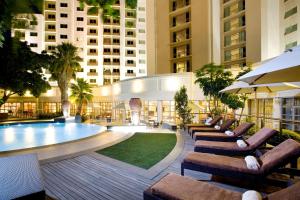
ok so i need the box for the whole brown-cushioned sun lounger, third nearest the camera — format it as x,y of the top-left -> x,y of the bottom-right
194,128 -> 278,156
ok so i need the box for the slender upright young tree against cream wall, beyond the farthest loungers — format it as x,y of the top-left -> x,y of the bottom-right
174,86 -> 192,127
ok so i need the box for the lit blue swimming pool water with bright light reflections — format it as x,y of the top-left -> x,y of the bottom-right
0,123 -> 106,152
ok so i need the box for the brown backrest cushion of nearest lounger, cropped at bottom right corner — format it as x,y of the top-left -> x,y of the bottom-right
267,182 -> 300,200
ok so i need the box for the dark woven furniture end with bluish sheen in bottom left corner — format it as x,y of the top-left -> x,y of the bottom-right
0,154 -> 46,200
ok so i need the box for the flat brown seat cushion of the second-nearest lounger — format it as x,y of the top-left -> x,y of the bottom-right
184,152 -> 261,174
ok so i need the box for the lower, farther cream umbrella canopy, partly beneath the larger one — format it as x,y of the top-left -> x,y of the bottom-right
220,81 -> 300,94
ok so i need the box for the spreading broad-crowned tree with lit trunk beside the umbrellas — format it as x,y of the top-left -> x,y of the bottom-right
195,63 -> 234,115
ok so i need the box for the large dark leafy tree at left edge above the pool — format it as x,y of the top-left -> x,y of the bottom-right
0,38 -> 50,106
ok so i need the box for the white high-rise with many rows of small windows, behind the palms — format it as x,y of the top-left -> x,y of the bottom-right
14,0 -> 147,85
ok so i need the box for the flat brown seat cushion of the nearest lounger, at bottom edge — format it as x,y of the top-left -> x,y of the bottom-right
151,173 -> 242,200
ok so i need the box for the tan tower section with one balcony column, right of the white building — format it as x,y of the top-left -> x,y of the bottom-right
148,0 -> 219,73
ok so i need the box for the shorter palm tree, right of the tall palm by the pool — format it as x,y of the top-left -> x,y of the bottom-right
70,78 -> 93,115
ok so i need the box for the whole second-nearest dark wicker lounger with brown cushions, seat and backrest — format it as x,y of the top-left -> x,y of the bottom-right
181,139 -> 300,181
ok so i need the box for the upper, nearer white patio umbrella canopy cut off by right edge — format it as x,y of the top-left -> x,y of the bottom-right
238,45 -> 300,84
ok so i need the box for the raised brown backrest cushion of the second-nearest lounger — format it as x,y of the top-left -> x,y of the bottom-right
260,139 -> 300,171
